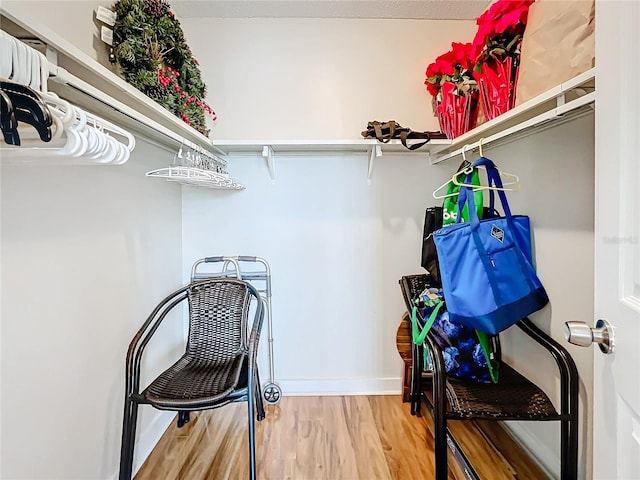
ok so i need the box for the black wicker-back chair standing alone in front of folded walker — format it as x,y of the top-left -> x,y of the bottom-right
120,278 -> 264,480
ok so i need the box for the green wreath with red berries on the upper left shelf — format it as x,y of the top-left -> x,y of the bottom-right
113,0 -> 215,136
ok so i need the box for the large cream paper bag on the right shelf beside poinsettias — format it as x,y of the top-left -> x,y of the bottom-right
516,0 -> 595,105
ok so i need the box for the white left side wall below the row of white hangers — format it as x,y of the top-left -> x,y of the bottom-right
0,141 -> 183,480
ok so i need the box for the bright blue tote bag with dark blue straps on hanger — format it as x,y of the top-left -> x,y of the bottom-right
433,157 -> 549,335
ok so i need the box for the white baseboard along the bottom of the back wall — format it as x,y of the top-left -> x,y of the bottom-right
277,377 -> 402,397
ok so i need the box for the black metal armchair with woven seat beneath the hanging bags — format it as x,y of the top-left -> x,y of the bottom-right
400,275 -> 579,480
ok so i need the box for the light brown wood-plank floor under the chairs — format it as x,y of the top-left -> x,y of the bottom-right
135,395 -> 547,480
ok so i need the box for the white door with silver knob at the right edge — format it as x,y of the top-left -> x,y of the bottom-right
593,0 -> 640,480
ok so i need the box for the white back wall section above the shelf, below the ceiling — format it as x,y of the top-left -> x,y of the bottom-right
181,18 -> 476,139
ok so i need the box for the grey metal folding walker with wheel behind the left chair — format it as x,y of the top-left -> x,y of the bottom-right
191,255 -> 282,405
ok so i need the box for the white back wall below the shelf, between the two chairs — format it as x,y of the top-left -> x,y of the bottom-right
183,156 -> 444,394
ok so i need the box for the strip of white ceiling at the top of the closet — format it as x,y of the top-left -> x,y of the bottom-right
171,0 -> 491,20
